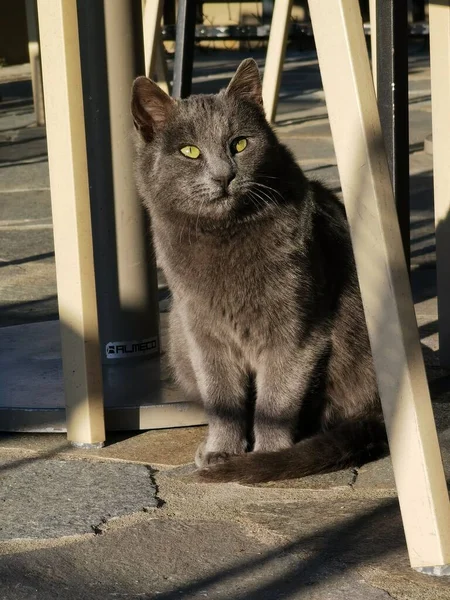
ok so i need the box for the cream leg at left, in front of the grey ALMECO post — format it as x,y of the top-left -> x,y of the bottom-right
38,0 -> 105,445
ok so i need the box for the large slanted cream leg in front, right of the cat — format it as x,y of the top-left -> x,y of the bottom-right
309,0 -> 450,574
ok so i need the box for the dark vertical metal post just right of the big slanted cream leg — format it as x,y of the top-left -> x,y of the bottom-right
377,0 -> 410,267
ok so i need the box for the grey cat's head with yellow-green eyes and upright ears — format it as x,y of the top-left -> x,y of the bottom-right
131,59 -> 280,220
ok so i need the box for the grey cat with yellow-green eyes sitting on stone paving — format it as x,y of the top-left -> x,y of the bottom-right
132,59 -> 386,482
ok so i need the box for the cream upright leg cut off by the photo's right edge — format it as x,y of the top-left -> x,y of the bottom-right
429,0 -> 450,367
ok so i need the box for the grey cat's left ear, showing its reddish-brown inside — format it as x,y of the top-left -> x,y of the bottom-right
131,77 -> 175,142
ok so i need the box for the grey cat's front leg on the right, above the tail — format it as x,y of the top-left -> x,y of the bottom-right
254,344 -> 322,452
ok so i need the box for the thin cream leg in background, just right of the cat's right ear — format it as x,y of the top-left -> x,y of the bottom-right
262,0 -> 292,123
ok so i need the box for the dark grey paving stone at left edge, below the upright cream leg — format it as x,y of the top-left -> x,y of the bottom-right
0,456 -> 157,540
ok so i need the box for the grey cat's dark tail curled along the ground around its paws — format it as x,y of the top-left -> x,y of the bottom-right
198,419 -> 388,483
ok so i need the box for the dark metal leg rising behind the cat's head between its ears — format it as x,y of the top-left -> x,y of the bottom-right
172,0 -> 197,98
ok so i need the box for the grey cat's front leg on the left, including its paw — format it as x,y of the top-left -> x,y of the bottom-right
191,339 -> 248,467
